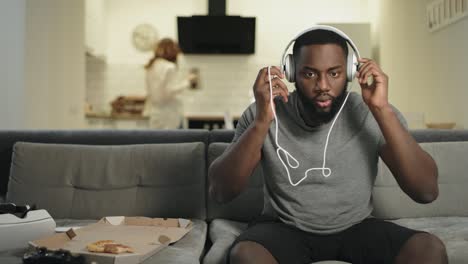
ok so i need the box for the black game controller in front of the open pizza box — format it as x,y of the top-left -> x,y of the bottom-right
23,247 -> 85,264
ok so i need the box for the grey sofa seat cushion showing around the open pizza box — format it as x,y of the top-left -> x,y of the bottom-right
0,219 -> 207,264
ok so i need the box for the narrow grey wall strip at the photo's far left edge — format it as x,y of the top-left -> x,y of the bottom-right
0,0 -> 25,129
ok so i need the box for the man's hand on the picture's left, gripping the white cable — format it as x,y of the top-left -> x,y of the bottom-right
253,66 -> 289,125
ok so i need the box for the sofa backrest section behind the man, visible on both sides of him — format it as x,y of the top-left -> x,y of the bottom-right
207,129 -> 468,220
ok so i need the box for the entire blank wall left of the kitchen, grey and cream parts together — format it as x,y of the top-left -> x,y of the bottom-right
0,0 -> 85,129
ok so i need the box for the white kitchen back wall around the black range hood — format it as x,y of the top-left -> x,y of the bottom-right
89,0 -> 370,115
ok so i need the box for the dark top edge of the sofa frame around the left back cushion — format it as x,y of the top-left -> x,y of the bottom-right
0,129 -> 210,197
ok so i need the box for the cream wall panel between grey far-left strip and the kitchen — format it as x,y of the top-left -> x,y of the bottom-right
23,0 -> 85,129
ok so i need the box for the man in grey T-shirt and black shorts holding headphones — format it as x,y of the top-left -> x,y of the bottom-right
209,26 -> 447,264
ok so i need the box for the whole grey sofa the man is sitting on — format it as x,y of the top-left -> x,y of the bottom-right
0,130 -> 468,264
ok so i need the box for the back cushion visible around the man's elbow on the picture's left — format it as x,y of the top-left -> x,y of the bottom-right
207,143 -> 263,221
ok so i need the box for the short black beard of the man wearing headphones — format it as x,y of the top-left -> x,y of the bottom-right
296,83 -> 348,125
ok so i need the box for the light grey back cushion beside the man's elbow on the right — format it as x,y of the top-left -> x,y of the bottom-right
373,142 -> 468,219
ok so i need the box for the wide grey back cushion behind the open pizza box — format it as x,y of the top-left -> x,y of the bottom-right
7,142 -> 206,219
